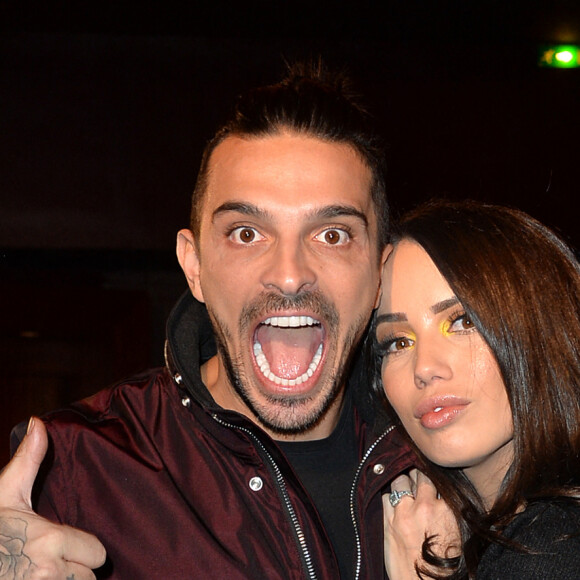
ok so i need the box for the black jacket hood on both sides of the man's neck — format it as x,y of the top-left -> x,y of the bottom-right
165,290 -> 390,433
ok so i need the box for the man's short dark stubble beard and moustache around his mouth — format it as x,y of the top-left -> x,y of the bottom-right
207,292 -> 368,435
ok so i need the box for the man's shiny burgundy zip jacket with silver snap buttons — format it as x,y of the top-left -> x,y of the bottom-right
13,294 -> 413,580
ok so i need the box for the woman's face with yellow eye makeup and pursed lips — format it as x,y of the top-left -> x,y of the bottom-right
377,240 -> 513,499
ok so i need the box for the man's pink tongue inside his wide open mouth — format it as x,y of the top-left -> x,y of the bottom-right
256,325 -> 322,379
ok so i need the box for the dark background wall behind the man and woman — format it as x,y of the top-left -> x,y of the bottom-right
0,0 -> 580,461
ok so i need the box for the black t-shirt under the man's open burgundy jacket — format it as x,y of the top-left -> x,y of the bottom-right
279,391 -> 358,580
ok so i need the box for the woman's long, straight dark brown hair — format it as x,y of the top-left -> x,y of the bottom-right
377,201 -> 580,578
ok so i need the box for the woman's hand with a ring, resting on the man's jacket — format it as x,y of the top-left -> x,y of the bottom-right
383,469 -> 460,580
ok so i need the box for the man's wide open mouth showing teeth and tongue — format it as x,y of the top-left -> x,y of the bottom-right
254,315 -> 324,387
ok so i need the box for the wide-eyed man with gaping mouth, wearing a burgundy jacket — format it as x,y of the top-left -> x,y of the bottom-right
0,64 -> 413,580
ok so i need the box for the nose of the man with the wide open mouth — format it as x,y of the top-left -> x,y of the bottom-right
262,240 -> 317,296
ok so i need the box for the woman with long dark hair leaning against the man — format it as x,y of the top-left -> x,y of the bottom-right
374,201 -> 580,580
